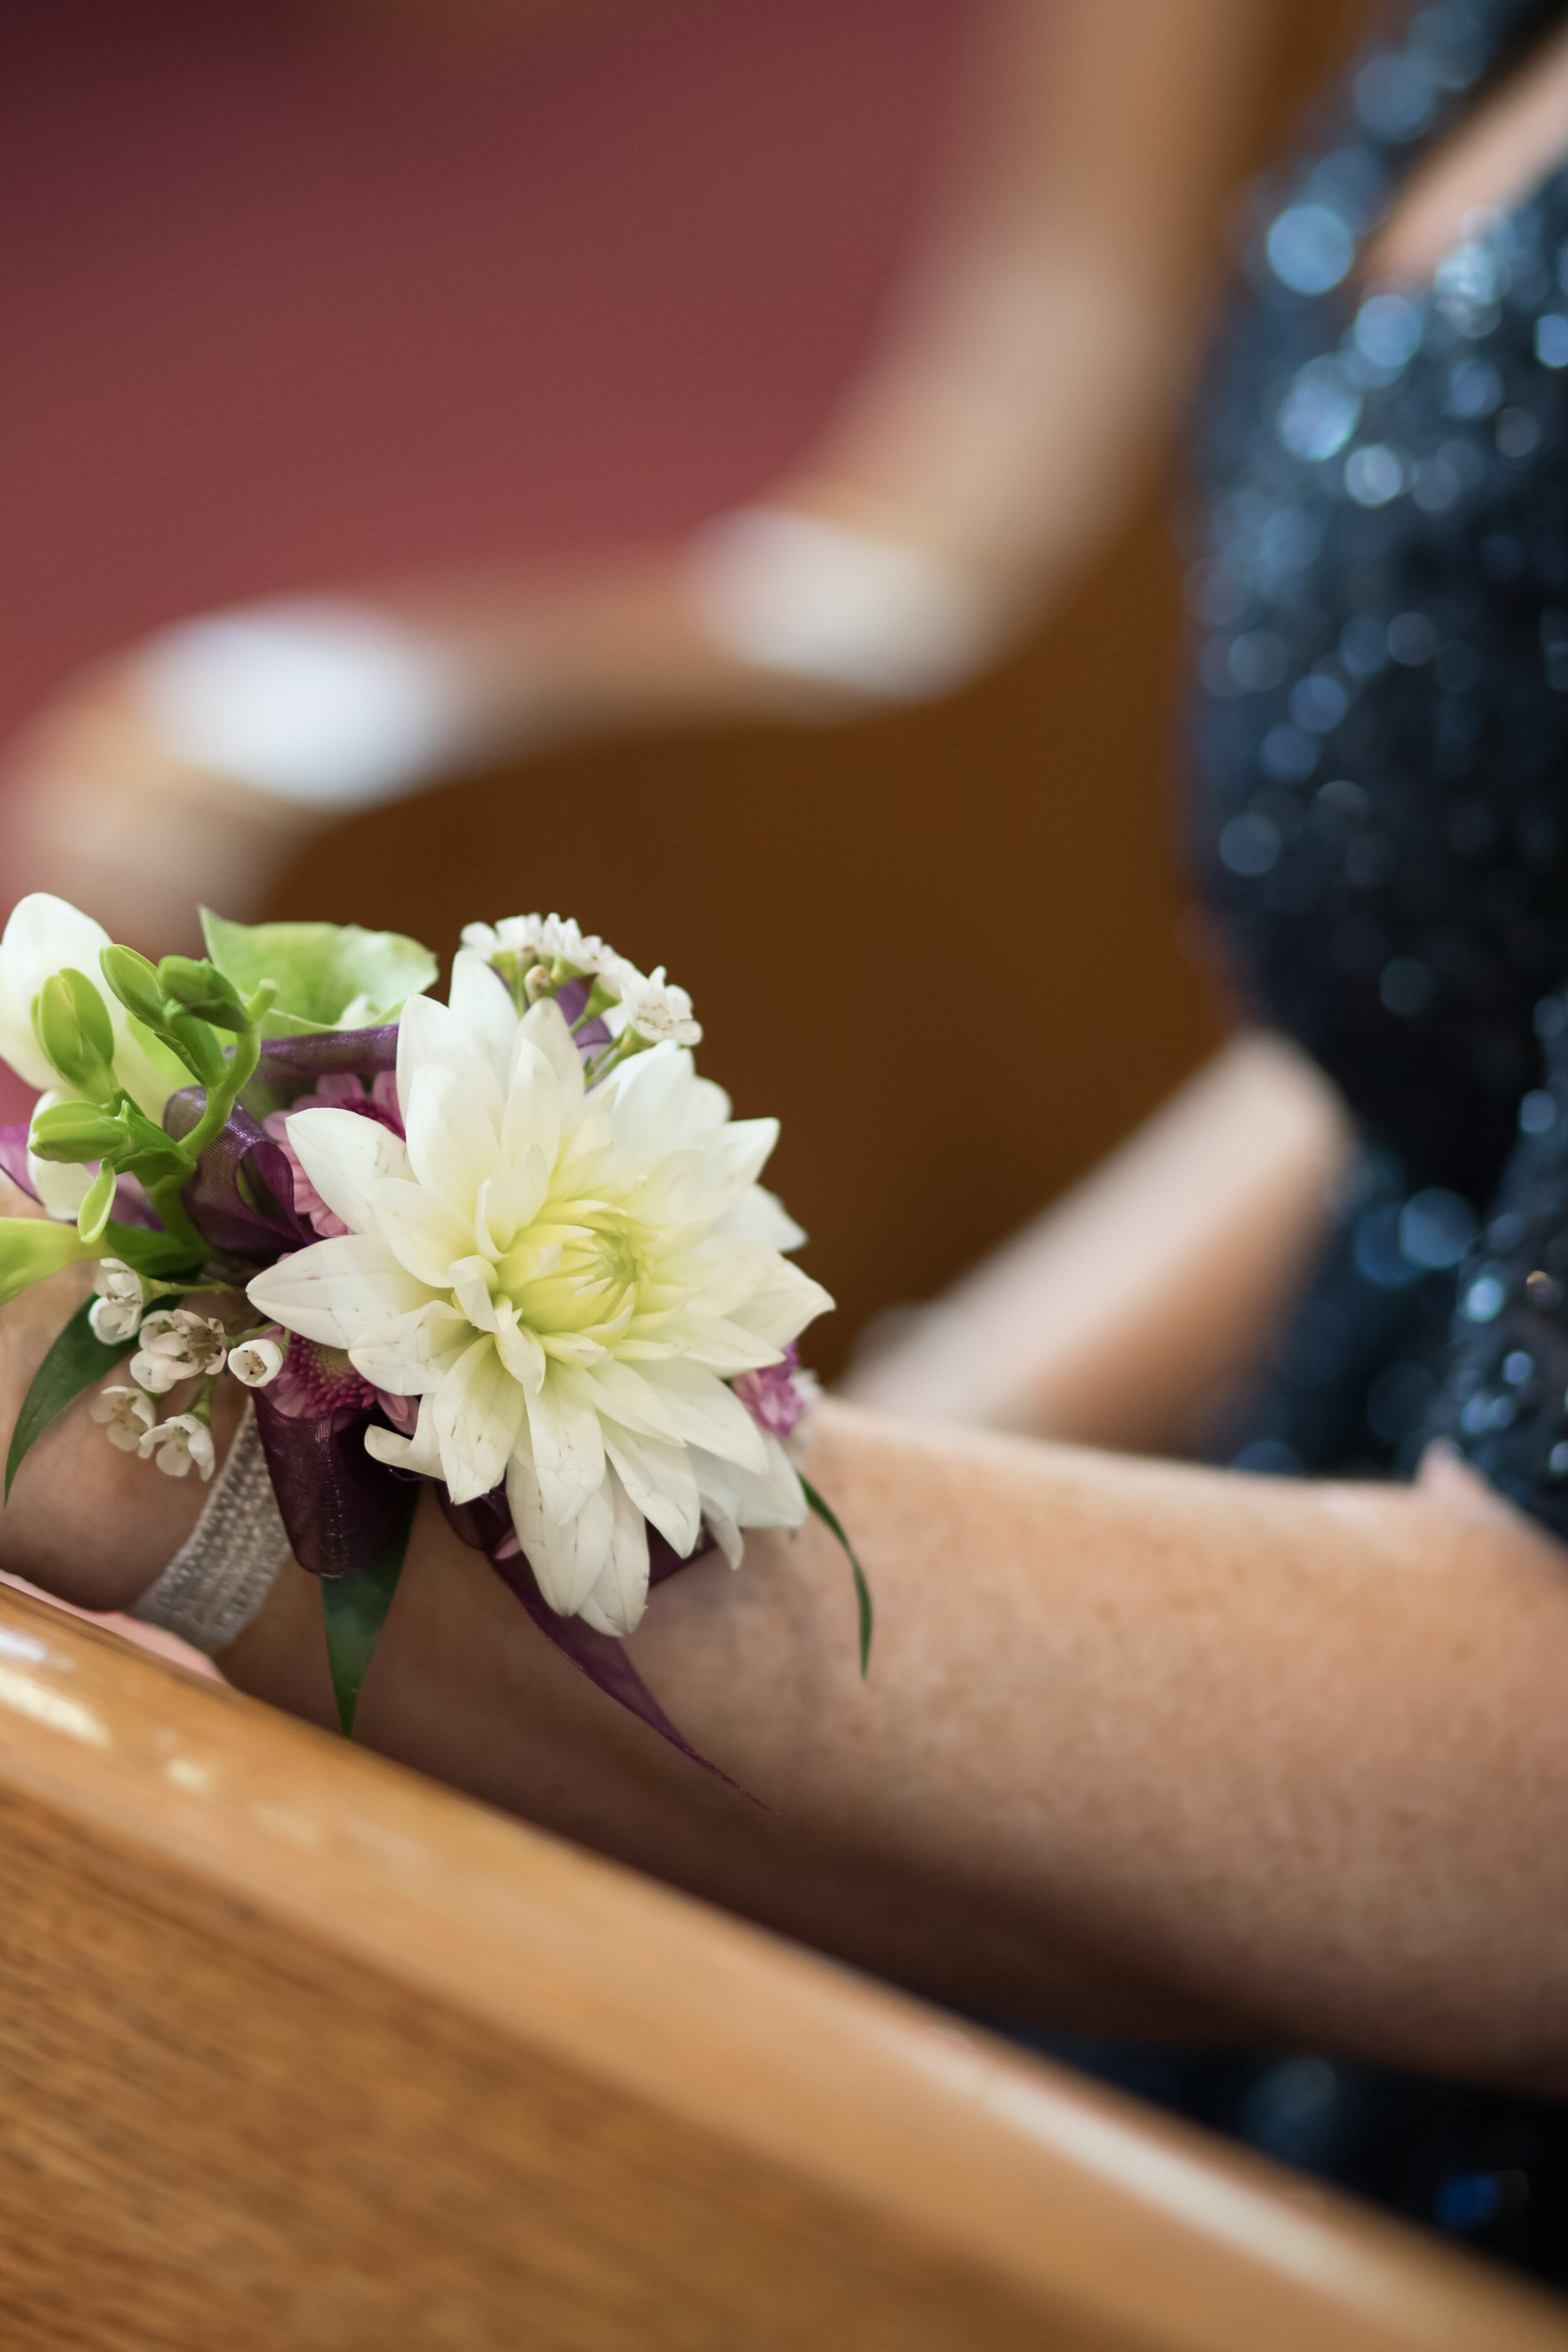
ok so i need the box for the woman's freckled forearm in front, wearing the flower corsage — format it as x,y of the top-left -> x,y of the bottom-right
223,1407 -> 1568,2089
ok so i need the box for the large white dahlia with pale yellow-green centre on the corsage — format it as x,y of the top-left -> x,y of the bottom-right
249,953 -> 832,1634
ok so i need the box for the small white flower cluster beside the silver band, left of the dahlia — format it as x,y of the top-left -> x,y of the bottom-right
87,1258 -> 282,1480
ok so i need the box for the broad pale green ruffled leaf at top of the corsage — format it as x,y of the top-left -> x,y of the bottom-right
202,908 -> 437,1037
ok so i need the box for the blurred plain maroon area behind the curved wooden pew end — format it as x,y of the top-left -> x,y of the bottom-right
0,0 -> 975,748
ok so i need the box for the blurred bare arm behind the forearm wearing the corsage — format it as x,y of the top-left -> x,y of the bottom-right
844,1030 -> 1349,1449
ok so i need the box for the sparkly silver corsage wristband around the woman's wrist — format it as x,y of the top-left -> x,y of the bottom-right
127,1402 -> 289,1658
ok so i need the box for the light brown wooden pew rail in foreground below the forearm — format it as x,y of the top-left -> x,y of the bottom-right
0,1592 -> 1568,2352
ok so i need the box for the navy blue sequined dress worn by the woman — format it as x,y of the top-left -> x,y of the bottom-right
1053,0 -> 1568,2286
